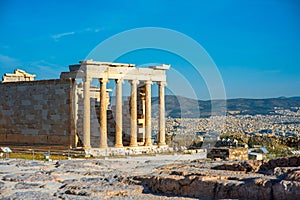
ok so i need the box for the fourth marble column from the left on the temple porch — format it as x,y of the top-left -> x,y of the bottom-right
130,80 -> 139,147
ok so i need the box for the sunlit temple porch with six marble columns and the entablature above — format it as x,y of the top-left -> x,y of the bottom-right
61,60 -> 170,148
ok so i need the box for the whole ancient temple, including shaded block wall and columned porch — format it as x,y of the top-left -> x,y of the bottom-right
0,60 -> 170,155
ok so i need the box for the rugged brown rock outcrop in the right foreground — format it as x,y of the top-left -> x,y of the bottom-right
142,156 -> 300,200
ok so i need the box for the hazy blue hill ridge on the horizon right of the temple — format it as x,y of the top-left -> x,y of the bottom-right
152,95 -> 300,118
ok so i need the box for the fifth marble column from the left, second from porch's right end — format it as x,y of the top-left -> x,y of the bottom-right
145,81 -> 152,146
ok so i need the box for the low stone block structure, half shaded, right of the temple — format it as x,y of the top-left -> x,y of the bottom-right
207,147 -> 248,160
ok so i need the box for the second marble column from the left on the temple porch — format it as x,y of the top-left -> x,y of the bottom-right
100,78 -> 108,148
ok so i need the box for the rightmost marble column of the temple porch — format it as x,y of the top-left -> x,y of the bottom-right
158,82 -> 166,146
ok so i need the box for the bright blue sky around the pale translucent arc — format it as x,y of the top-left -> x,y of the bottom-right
0,0 -> 300,99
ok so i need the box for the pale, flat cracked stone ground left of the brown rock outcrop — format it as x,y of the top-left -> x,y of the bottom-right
0,155 -> 199,200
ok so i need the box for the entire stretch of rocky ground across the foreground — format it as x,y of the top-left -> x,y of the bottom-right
0,154 -> 300,199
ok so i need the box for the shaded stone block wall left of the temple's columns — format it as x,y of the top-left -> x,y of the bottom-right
0,80 -> 75,147
